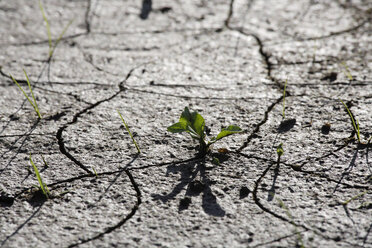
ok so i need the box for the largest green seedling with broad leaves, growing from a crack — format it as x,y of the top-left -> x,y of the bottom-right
168,107 -> 242,156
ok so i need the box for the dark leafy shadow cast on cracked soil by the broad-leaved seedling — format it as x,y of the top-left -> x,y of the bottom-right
152,158 -> 226,217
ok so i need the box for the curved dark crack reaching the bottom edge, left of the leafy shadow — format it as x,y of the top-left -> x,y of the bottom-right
68,170 -> 142,248
